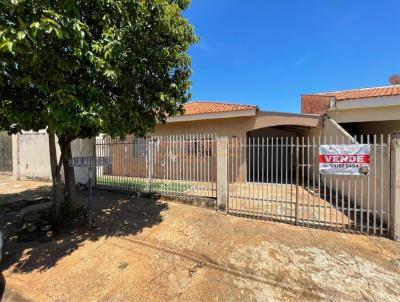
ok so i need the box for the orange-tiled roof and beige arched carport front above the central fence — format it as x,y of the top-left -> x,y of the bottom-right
152,101 -> 322,138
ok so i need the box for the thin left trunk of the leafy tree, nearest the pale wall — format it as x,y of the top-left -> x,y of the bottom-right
49,132 -> 62,222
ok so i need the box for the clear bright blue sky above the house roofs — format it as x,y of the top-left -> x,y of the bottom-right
185,0 -> 400,112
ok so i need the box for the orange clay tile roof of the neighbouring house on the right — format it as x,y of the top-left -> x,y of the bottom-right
311,85 -> 400,101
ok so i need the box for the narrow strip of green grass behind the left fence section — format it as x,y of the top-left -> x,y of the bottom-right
97,176 -> 191,192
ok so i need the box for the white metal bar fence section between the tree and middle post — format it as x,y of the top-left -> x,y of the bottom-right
96,134 -> 216,198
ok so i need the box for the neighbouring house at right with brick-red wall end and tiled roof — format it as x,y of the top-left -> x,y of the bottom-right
301,85 -> 400,135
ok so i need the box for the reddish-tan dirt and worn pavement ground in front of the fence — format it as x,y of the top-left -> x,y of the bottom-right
0,178 -> 400,301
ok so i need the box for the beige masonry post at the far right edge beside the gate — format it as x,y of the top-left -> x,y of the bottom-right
389,132 -> 400,241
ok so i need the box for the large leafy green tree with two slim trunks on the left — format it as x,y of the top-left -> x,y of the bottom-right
0,0 -> 197,218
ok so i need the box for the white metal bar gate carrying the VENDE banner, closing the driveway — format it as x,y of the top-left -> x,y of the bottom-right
228,135 -> 390,235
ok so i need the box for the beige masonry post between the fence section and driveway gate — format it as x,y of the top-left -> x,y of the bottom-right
216,136 -> 229,212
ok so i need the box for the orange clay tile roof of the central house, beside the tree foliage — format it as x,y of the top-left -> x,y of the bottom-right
184,101 -> 258,115
